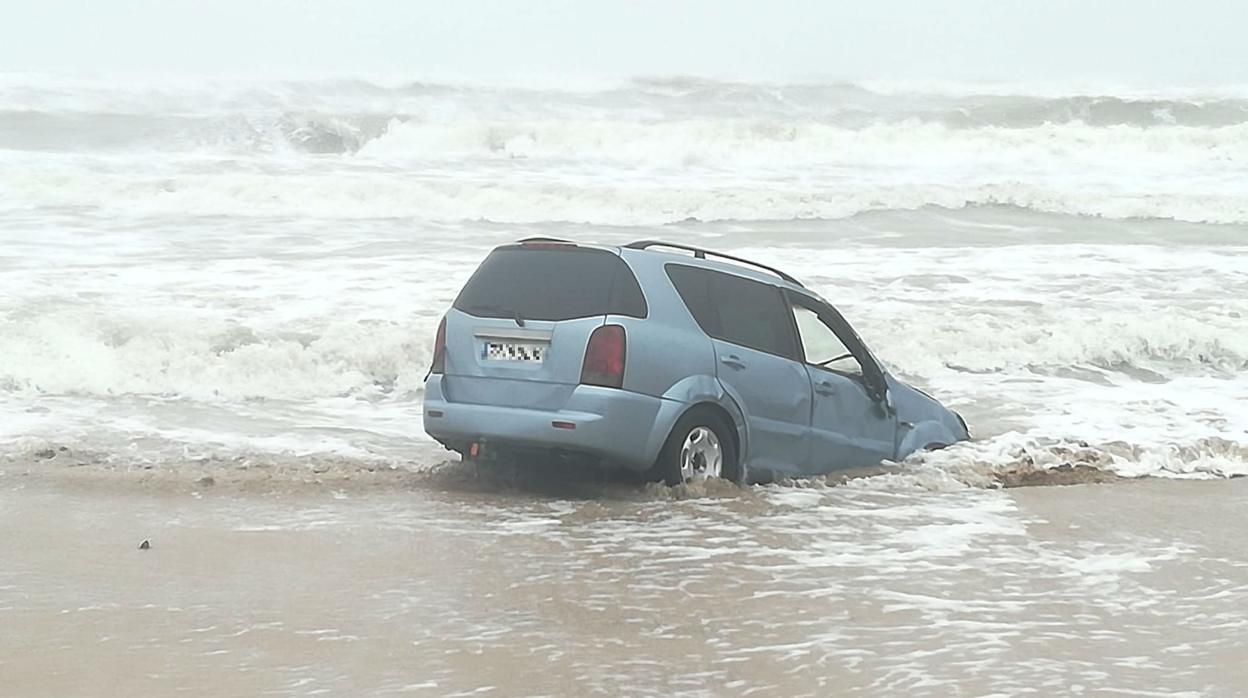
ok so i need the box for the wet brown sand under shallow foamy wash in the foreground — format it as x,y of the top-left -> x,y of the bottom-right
0,469 -> 1248,696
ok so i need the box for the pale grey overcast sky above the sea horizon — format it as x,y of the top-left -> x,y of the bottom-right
0,0 -> 1248,86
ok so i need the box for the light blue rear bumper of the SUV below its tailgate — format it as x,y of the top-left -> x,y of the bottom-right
423,376 -> 681,471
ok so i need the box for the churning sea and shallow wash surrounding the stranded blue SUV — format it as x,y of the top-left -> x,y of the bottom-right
0,75 -> 1248,696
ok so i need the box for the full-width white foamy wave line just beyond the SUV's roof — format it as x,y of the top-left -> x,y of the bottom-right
7,169 -> 1248,225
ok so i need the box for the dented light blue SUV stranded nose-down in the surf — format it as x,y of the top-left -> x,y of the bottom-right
423,237 -> 970,484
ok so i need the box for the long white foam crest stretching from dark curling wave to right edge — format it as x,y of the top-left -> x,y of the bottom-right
351,116 -> 1248,169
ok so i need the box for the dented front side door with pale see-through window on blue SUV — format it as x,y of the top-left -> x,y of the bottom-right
789,292 -> 897,473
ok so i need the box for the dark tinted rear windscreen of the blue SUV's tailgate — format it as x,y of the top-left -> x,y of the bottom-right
454,246 -> 646,321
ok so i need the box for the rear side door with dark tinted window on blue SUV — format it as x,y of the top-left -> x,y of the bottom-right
668,265 -> 811,474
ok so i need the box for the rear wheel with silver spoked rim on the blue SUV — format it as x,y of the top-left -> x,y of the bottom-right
655,408 -> 745,487
